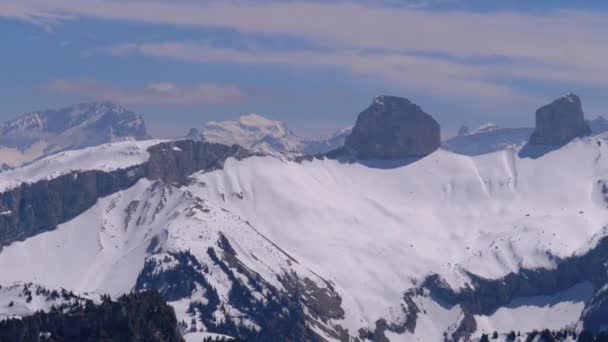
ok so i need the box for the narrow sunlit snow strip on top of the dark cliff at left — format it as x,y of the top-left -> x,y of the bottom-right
0,140 -> 163,191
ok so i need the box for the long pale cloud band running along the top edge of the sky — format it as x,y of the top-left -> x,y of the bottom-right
0,0 -> 608,67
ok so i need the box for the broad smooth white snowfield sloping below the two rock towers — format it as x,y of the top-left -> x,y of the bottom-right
190,138 -> 608,329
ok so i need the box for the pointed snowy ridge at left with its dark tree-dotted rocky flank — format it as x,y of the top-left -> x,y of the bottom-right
0,179 -> 340,340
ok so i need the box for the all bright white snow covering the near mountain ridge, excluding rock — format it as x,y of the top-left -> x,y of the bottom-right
0,138 -> 608,341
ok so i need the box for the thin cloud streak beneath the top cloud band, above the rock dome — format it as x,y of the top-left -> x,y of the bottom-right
104,42 -> 533,103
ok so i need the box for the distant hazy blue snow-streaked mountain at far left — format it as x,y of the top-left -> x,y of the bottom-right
0,102 -> 147,169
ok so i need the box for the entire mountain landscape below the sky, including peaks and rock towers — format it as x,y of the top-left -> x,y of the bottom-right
0,94 -> 608,342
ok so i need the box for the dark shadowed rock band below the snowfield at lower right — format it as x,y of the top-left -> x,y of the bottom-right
411,231 -> 608,332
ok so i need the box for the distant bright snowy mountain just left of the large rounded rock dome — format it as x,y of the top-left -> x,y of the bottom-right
185,114 -> 351,154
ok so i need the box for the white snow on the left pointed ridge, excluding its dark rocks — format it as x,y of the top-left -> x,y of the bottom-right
0,179 -> 334,338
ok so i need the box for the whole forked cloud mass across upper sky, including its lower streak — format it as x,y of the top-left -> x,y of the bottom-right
0,0 -> 608,101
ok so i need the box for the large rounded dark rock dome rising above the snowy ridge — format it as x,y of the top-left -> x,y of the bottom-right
344,96 -> 441,159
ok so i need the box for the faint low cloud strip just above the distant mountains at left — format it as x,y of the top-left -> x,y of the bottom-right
42,79 -> 246,104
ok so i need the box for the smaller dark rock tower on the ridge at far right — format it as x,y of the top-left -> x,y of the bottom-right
530,94 -> 591,145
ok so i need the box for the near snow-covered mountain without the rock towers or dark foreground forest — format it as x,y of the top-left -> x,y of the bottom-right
0,137 -> 608,341
